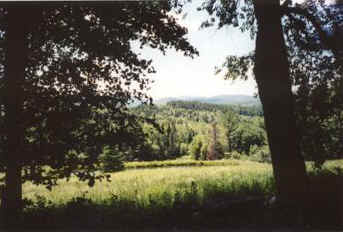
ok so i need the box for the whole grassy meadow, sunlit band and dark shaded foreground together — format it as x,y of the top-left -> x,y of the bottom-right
2,159 -> 343,228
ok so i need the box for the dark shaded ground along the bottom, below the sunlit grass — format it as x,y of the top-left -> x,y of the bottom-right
0,171 -> 343,230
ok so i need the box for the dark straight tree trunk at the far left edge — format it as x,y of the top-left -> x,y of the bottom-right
3,6 -> 28,227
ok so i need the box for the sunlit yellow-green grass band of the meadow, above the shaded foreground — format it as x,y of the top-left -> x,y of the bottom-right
24,160 -> 273,206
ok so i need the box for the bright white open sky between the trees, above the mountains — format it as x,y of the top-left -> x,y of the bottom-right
136,1 -> 256,98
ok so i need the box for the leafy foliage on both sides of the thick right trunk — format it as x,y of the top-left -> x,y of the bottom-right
199,0 -> 343,165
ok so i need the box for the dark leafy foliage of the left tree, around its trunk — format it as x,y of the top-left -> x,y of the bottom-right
0,1 -> 198,186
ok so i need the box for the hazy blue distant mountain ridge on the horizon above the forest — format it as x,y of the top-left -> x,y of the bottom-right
154,95 -> 260,105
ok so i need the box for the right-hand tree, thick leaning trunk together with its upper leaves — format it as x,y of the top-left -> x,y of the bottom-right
200,0 -> 341,210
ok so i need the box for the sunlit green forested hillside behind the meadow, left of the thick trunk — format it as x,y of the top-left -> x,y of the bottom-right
101,101 -> 269,169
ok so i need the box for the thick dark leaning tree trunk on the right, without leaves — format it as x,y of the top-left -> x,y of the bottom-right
254,0 -> 308,206
